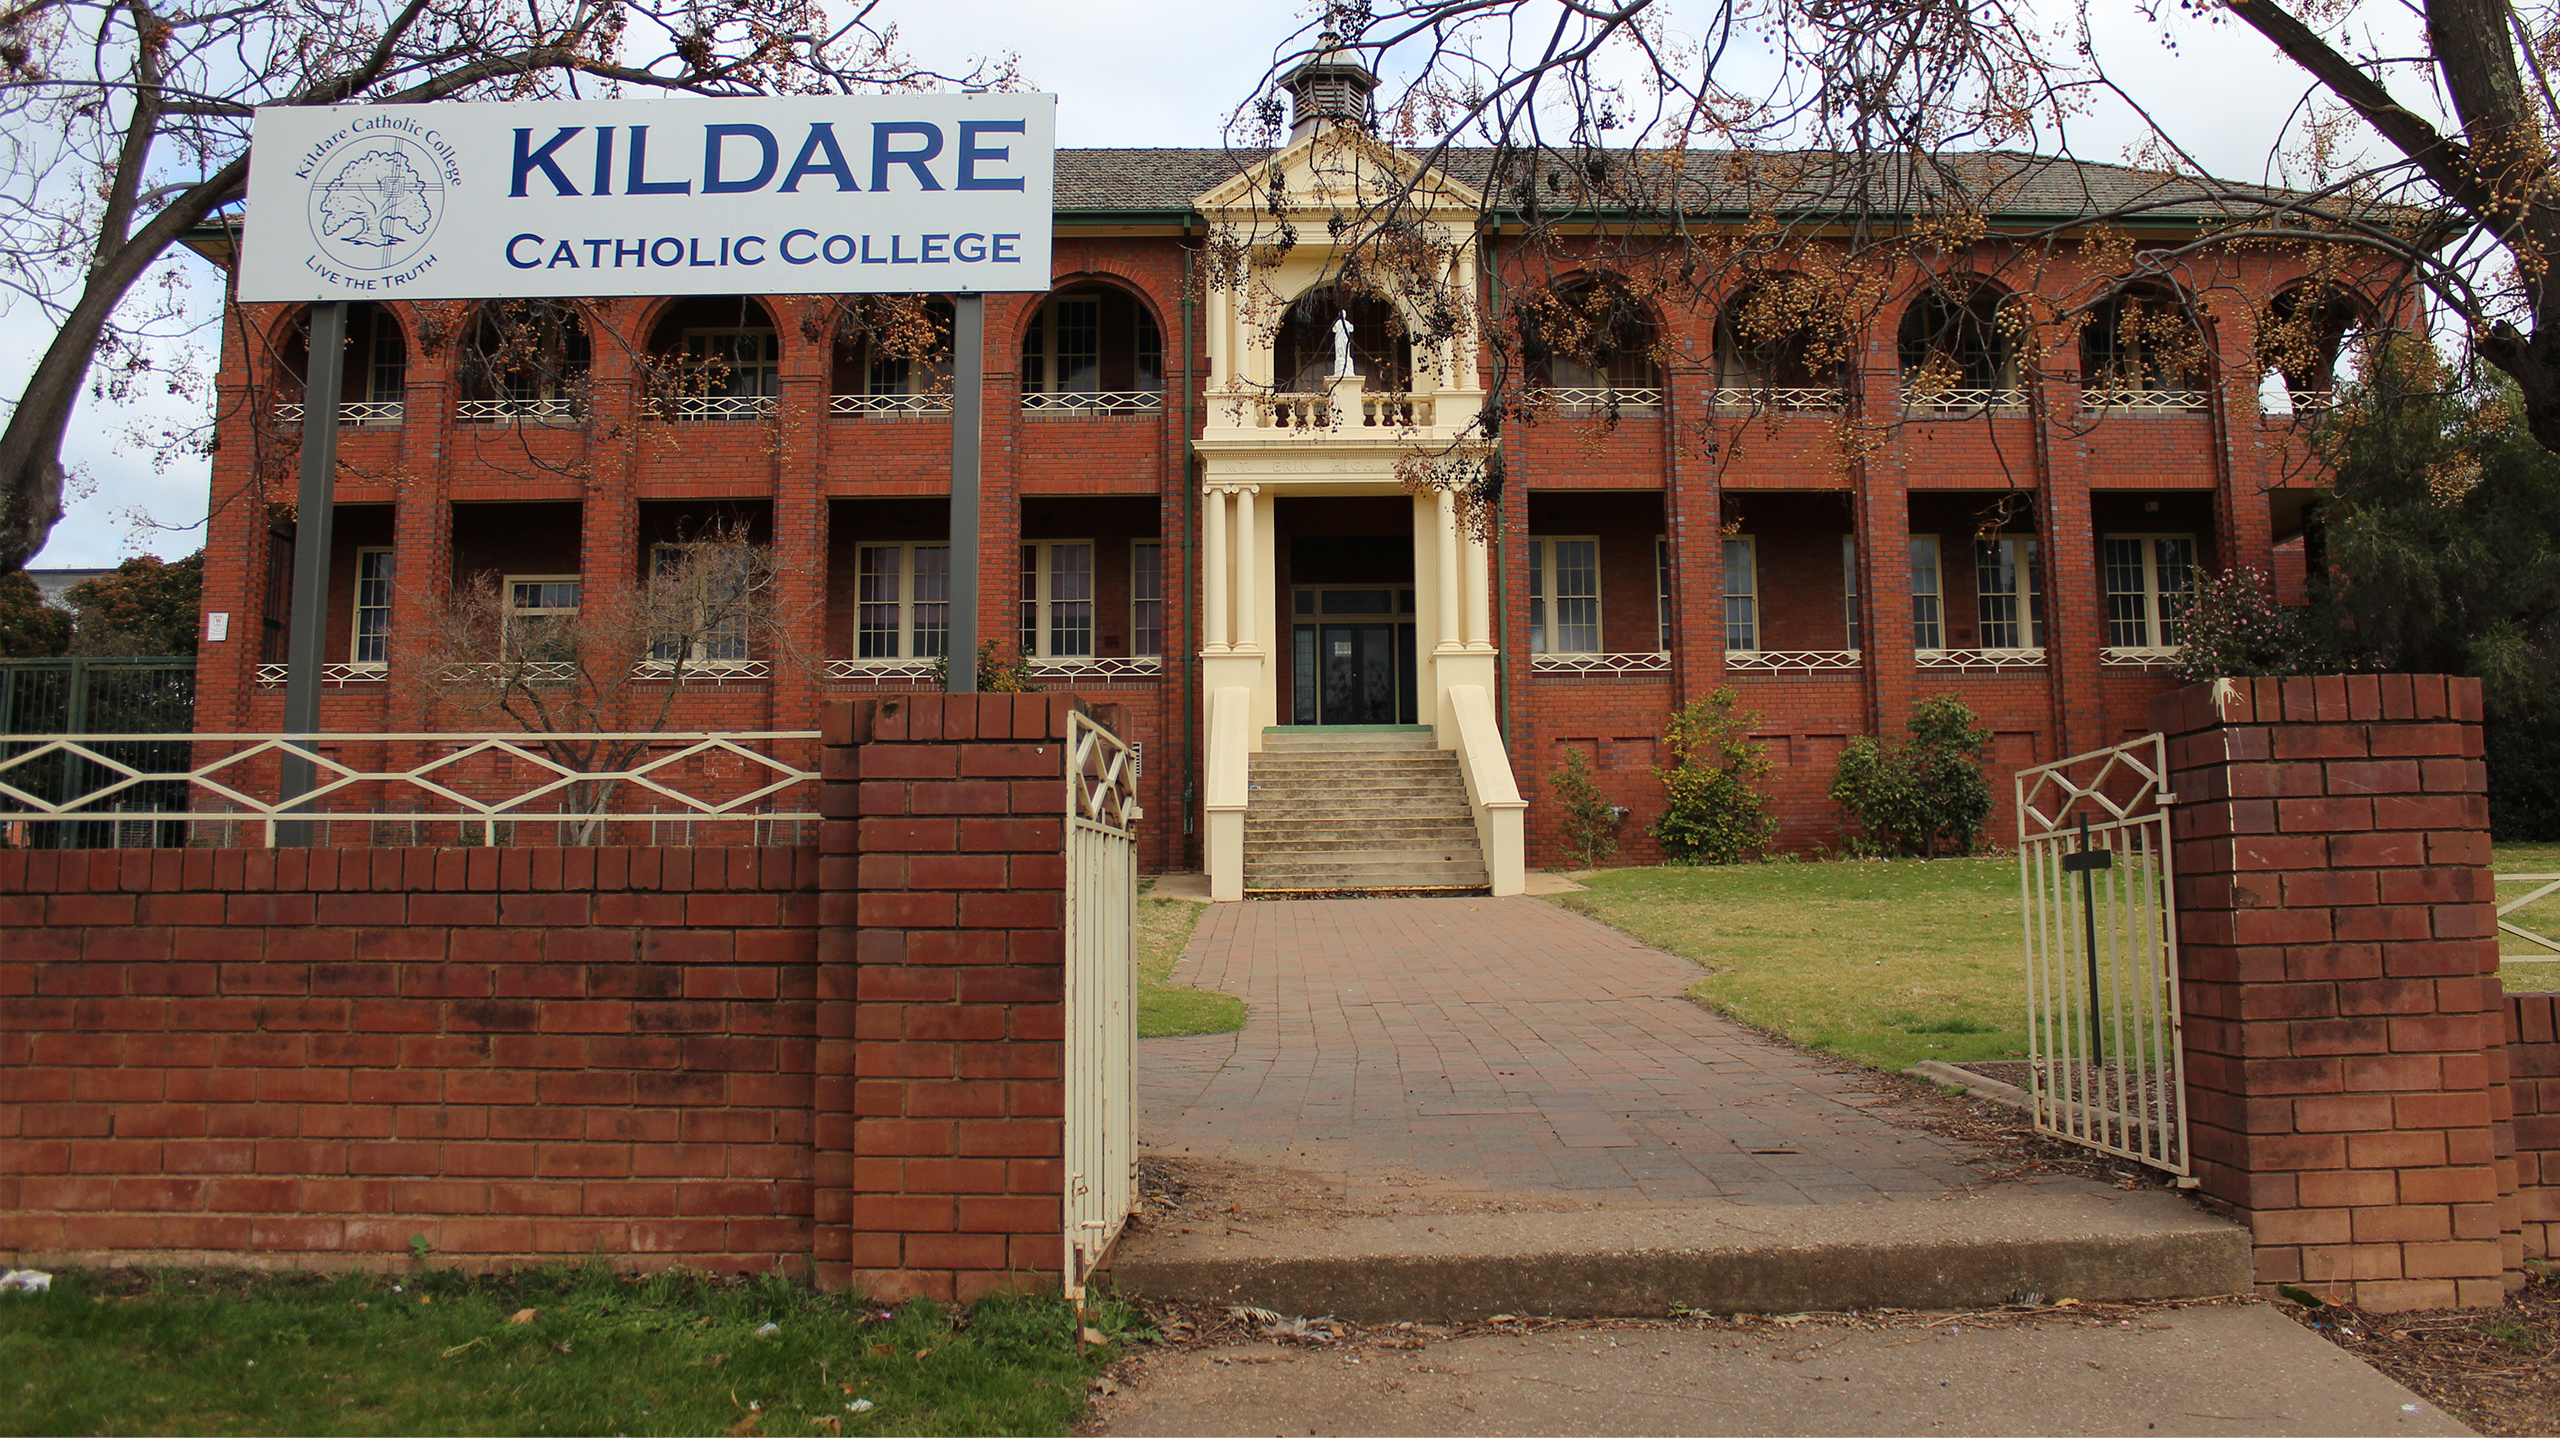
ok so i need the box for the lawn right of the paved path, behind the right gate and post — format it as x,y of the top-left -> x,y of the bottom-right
1556,844 -> 2560,1070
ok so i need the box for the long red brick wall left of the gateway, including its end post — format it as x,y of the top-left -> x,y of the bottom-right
0,696 -> 1100,1297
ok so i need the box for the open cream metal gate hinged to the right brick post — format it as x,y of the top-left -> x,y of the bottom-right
2017,734 -> 2191,1182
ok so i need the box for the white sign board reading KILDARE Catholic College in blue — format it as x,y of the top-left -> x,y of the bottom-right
241,95 -> 1057,299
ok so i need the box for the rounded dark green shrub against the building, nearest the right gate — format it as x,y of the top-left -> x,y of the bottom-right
1830,693 -> 1992,857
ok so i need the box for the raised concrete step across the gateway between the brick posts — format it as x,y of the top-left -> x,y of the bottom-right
1111,1185 -> 2253,1323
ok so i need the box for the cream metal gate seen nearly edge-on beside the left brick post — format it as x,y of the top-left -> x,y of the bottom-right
1065,714 -> 1139,1302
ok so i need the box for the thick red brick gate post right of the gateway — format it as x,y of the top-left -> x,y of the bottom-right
2150,676 -> 2516,1310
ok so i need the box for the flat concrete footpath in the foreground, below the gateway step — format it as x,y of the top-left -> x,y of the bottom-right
1088,1302 -> 2470,1435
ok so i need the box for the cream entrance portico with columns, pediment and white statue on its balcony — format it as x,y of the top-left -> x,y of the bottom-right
1193,126 -> 1526,898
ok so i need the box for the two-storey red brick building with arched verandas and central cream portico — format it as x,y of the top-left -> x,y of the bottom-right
197,81 -> 2327,893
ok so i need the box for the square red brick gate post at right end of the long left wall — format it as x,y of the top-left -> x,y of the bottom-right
814,693 -> 1078,1300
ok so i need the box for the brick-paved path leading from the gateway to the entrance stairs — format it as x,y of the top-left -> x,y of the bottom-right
1139,898 -> 1981,1205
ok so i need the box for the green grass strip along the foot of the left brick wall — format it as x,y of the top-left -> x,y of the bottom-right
0,1267 -> 1126,1438
